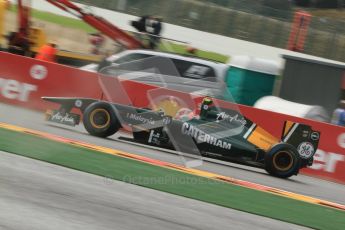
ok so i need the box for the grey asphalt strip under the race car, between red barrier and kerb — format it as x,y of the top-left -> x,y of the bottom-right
0,104 -> 345,207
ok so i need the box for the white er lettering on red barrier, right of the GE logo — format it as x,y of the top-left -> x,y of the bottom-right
310,149 -> 345,173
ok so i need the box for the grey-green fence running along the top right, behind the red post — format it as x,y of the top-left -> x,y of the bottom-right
77,0 -> 345,61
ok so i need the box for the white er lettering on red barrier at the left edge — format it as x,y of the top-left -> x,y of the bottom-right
0,78 -> 37,101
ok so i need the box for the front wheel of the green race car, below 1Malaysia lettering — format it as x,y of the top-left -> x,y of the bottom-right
83,102 -> 121,137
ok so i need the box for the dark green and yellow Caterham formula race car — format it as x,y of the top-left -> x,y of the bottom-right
43,97 -> 320,178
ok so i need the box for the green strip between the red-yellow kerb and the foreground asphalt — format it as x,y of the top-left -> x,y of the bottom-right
0,128 -> 345,230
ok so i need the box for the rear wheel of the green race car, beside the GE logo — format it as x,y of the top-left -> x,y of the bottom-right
265,143 -> 300,178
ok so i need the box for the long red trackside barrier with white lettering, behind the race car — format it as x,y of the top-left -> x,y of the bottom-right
0,52 -> 345,183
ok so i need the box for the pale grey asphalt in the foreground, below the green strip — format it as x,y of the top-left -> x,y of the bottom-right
0,151 -> 314,230
